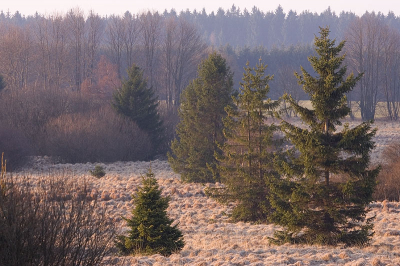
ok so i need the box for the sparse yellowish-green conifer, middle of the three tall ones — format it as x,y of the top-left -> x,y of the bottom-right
207,60 -> 279,222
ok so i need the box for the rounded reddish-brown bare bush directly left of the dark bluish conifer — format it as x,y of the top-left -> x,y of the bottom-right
45,107 -> 151,163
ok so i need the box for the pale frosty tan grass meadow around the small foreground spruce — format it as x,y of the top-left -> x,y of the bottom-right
19,121 -> 400,266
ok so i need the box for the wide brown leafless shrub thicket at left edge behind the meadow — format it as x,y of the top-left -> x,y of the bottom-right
0,86 -> 164,163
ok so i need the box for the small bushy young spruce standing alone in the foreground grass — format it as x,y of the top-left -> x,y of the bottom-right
116,169 -> 184,256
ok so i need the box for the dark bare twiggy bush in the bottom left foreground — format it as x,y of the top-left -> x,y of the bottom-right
0,169 -> 115,266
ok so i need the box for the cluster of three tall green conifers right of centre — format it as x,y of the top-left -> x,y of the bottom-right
169,28 -> 379,246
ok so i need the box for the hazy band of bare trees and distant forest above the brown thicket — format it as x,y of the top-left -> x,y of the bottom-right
0,5 -> 400,119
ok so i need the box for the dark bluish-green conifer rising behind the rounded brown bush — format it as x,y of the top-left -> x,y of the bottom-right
112,65 -> 164,153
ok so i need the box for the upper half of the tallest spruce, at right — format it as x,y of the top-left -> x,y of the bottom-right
291,28 -> 361,132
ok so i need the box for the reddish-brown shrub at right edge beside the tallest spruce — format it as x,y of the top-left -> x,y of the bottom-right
374,143 -> 400,201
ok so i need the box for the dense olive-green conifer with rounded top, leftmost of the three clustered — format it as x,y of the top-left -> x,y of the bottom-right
168,53 -> 233,182
